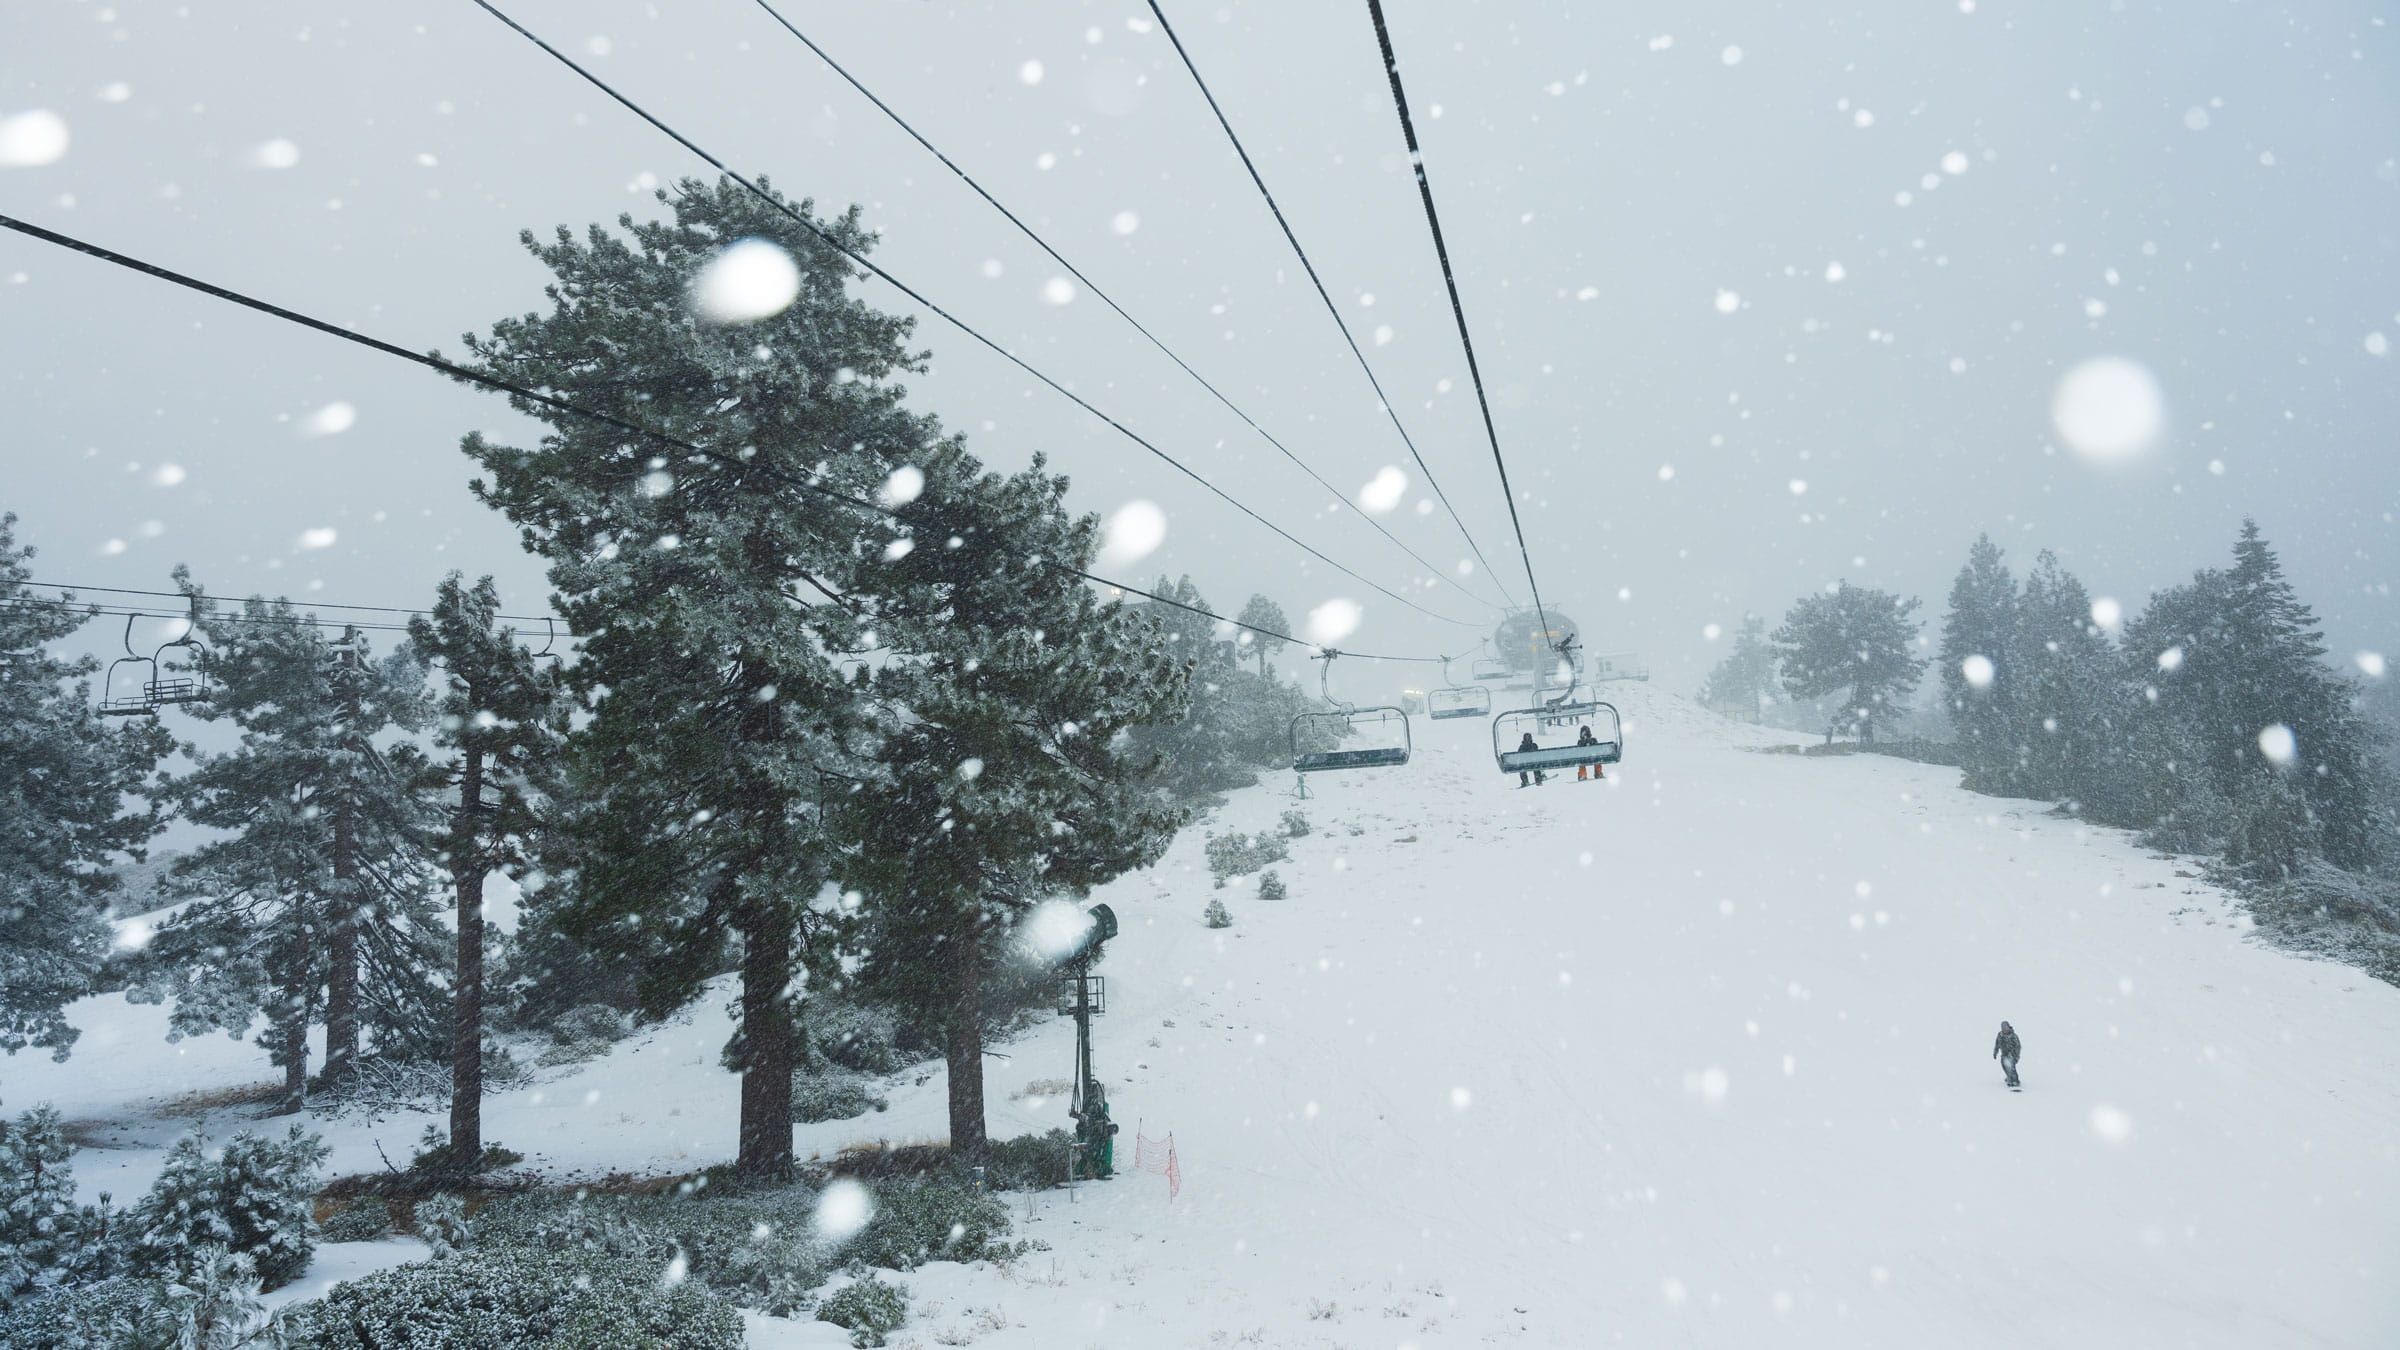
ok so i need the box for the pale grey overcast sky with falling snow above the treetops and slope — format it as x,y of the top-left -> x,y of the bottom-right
0,0 -> 2400,694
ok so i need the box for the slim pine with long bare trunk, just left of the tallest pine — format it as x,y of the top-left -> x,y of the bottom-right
408,572 -> 566,1172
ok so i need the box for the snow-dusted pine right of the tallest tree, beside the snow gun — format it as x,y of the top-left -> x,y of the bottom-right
838,440 -> 1195,1158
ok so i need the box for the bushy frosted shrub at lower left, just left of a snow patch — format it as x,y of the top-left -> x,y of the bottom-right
130,1124 -> 326,1290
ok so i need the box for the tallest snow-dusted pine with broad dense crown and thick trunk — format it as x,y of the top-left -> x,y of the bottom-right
446,180 -> 946,1175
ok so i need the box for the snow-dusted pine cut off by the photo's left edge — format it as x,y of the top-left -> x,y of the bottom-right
0,516 -> 173,1059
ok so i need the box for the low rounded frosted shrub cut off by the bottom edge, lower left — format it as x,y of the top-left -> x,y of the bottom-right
293,1249 -> 742,1350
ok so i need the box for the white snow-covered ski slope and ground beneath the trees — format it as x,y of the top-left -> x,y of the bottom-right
0,685 -> 2400,1348
